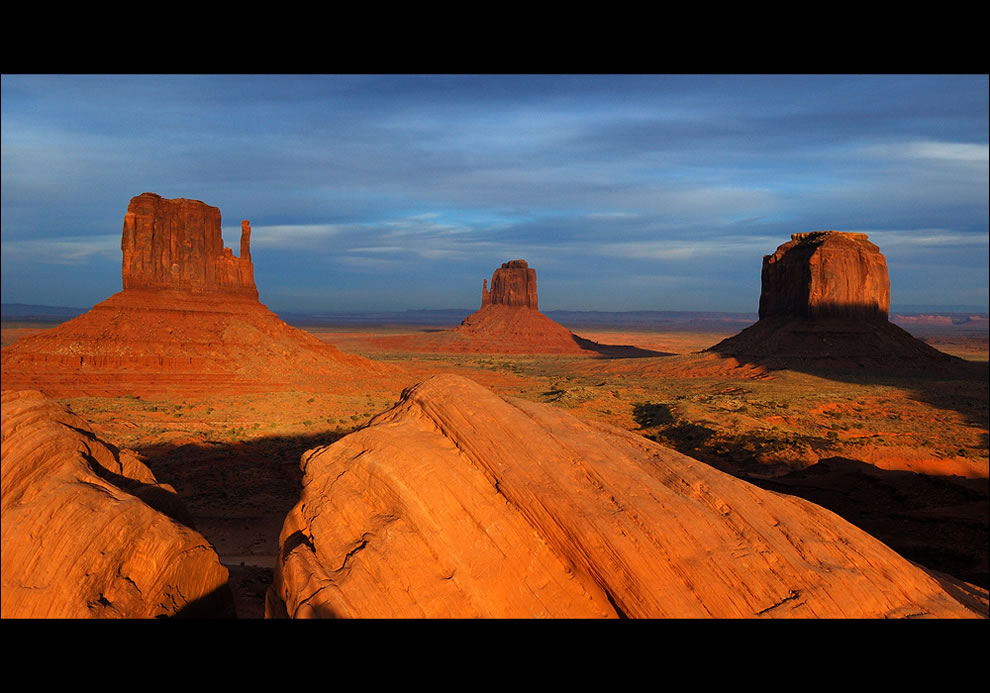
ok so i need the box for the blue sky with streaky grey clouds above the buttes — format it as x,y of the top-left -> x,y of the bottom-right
0,74 -> 990,312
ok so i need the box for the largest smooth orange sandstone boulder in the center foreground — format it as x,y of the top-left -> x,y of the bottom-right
266,375 -> 986,618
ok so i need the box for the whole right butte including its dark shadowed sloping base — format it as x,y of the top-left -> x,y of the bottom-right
708,231 -> 960,371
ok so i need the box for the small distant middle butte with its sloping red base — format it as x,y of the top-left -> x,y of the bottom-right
375,260 -> 669,359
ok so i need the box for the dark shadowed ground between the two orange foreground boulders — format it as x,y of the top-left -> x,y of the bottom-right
138,431 -> 349,618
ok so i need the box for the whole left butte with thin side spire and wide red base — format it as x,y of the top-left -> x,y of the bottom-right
0,193 -> 388,397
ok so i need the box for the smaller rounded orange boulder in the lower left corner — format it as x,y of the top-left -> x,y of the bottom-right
0,391 -> 233,619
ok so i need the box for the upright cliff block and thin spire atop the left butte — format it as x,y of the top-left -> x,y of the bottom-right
120,193 -> 258,300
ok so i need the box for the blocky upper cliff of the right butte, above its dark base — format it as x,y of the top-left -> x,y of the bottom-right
760,231 -> 890,320
